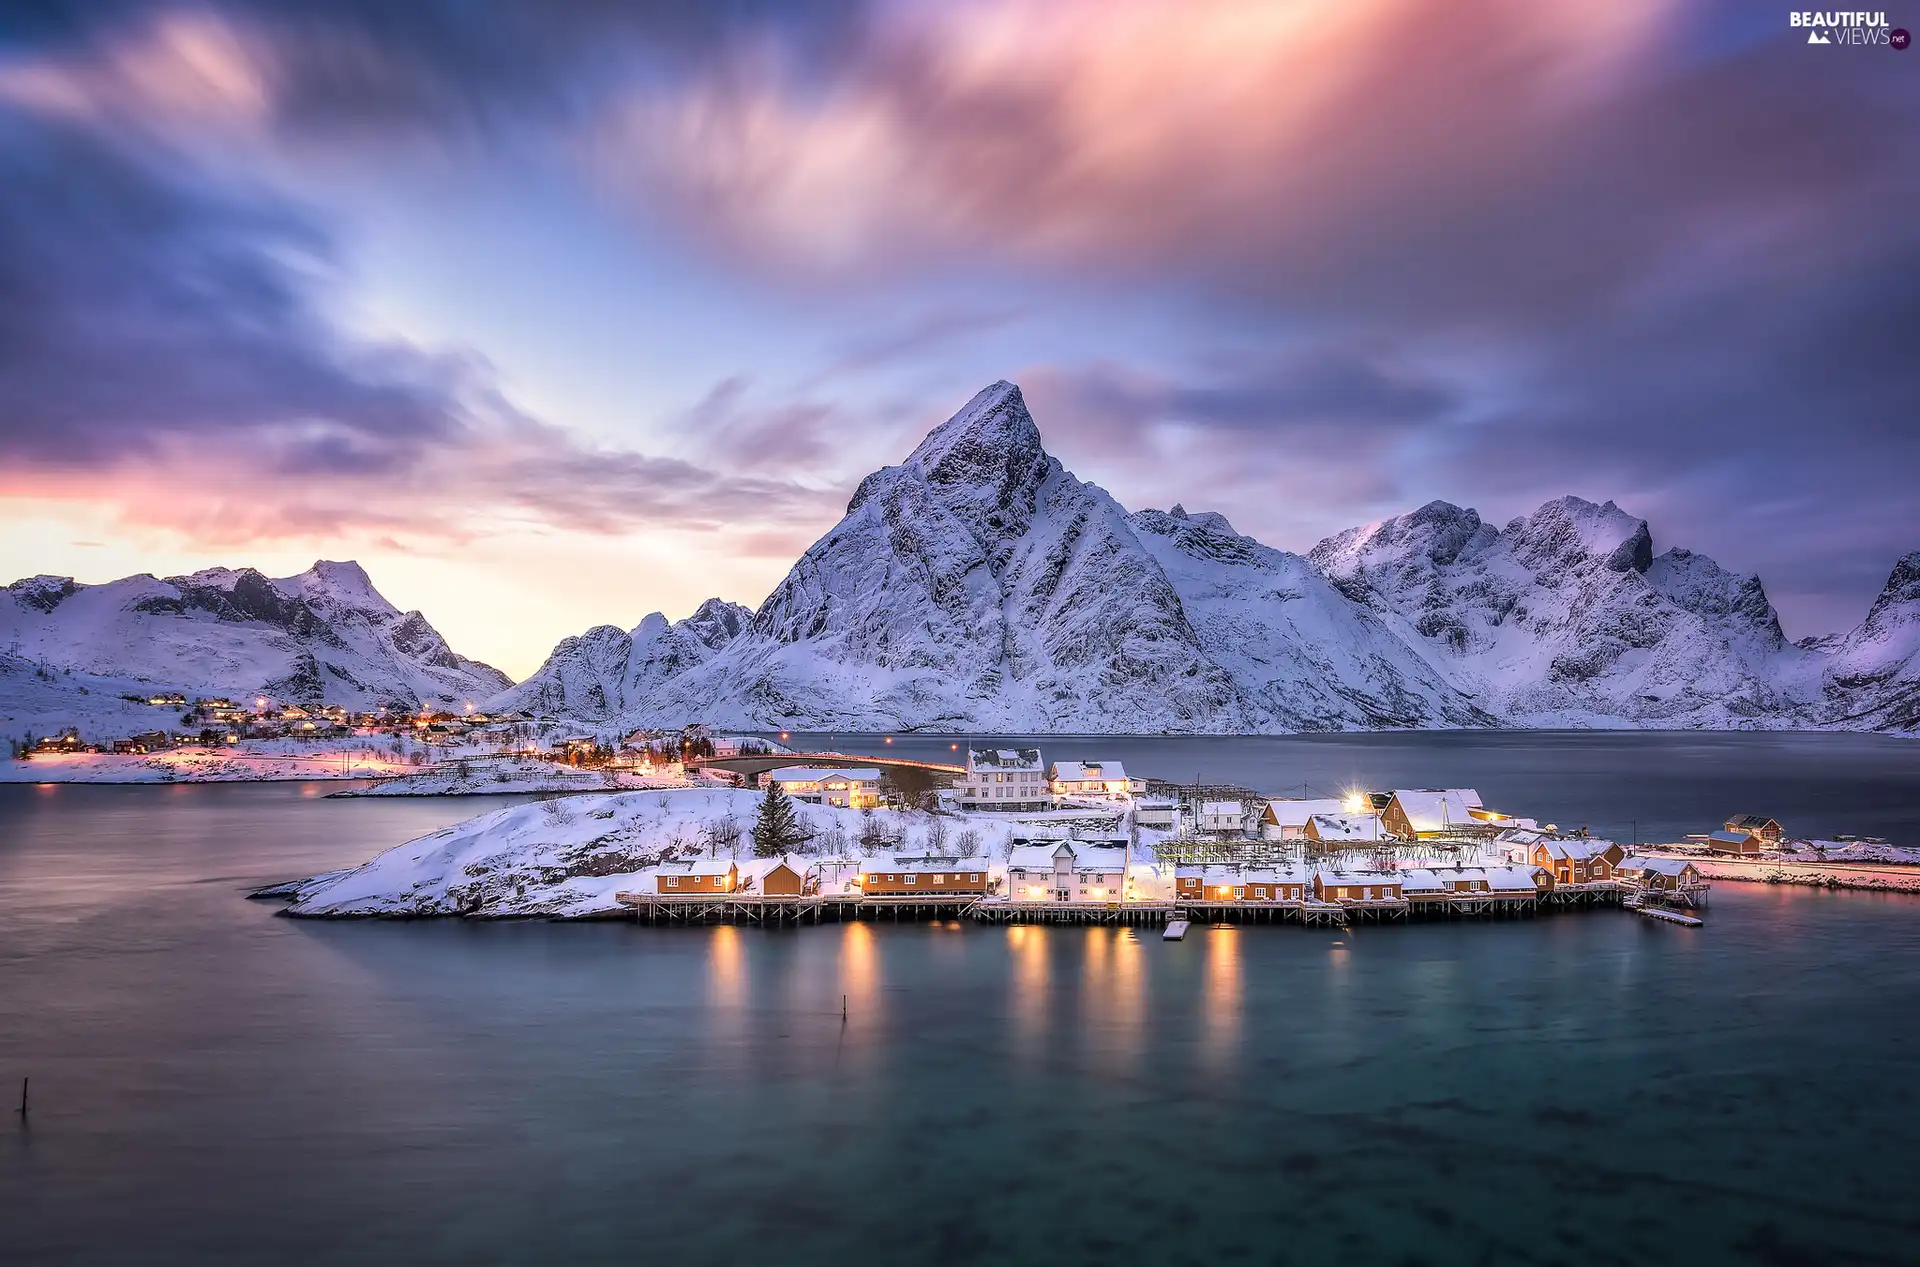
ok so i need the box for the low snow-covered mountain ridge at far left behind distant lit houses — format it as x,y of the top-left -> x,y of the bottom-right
0,561 -> 511,731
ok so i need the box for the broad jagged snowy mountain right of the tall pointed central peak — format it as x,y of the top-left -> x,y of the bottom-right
1309,497 -> 1818,728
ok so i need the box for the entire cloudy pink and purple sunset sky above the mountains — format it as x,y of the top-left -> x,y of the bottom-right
0,0 -> 1920,678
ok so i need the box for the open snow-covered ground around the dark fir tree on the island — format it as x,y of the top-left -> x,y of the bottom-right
276,787 -> 1016,920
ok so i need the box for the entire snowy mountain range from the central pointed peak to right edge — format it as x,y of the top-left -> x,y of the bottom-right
499,382 -> 1920,733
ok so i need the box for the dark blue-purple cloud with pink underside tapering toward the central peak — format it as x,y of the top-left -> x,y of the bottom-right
0,113 -> 829,543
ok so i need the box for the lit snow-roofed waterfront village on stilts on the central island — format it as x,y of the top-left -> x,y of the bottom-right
618,745 -> 1735,935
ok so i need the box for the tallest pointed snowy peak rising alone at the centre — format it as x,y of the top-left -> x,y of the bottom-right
622,382 -> 1248,731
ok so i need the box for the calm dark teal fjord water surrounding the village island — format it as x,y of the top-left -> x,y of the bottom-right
0,735 -> 1920,1265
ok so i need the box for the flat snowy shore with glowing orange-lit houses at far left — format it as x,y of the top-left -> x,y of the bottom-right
0,739 -> 415,783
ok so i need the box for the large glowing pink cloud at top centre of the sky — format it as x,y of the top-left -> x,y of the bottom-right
599,0 -> 1668,271
